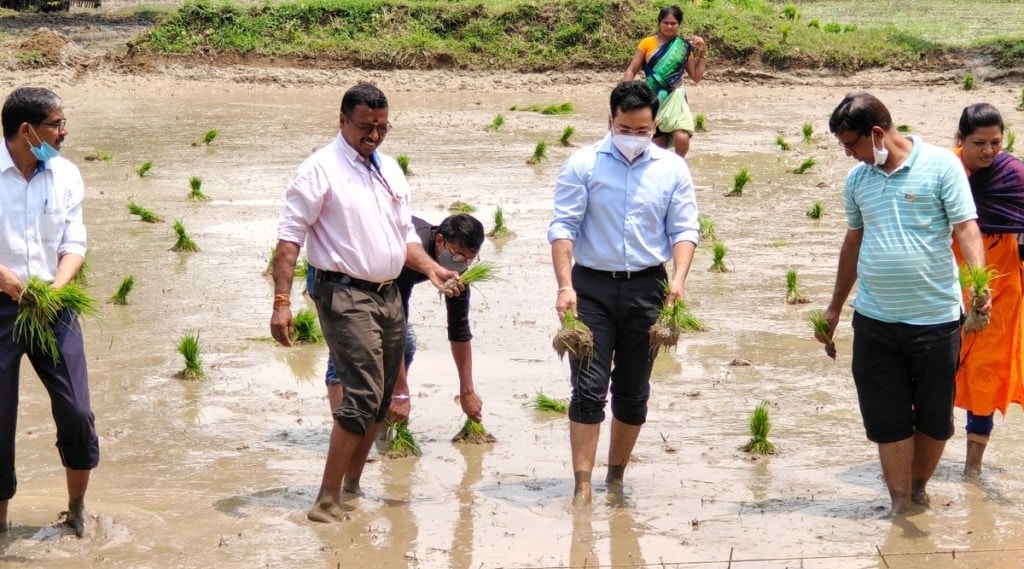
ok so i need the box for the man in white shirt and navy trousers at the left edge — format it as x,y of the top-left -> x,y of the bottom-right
0,87 -> 99,537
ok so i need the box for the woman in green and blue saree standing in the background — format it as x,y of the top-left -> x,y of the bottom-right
623,6 -> 708,157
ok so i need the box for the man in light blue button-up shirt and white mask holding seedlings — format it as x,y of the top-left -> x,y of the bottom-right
548,81 -> 698,506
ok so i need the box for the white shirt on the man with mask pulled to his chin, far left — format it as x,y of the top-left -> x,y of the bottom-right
0,142 -> 85,283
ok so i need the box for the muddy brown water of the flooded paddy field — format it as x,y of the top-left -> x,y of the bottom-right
0,69 -> 1024,569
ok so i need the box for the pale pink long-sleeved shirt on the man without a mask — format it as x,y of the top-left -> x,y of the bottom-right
278,133 -> 420,282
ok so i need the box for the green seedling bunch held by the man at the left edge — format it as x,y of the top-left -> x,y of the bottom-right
13,275 -> 98,363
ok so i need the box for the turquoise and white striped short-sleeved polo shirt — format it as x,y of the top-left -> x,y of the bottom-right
844,136 -> 978,324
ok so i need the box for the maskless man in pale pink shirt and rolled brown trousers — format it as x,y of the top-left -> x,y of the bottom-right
270,83 -> 459,522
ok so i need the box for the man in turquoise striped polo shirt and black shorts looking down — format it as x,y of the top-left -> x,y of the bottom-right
819,92 -> 991,515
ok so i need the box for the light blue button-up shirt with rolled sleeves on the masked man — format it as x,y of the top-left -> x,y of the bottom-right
548,133 -> 699,271
